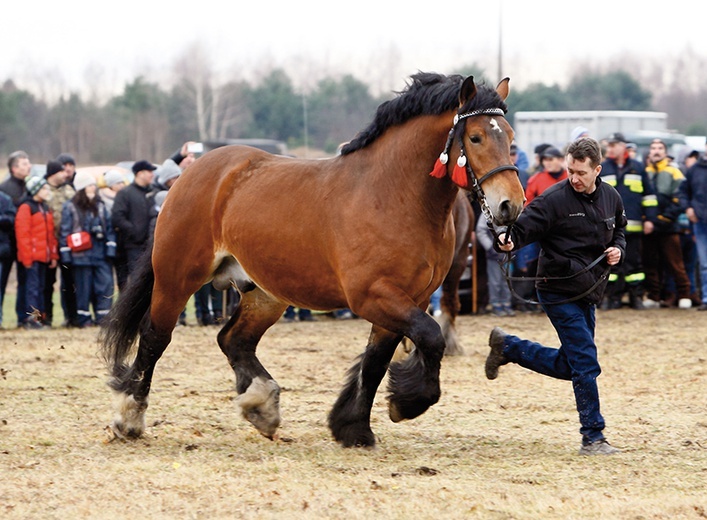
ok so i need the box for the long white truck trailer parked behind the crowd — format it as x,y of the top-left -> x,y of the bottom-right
513,110 -> 686,159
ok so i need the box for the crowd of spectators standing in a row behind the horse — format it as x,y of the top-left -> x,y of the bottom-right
0,134 -> 707,329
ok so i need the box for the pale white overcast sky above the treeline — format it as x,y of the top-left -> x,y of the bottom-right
0,0 -> 707,98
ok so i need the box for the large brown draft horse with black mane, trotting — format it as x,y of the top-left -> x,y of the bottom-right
101,73 -> 524,446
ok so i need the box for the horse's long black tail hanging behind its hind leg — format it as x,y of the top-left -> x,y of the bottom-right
99,249 -> 155,378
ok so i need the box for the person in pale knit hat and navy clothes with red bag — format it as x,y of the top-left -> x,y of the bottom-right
59,172 -> 116,328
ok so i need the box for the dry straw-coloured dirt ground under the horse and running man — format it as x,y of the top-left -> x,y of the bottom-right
0,310 -> 707,519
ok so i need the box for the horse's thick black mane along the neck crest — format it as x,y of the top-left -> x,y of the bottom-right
341,72 -> 507,155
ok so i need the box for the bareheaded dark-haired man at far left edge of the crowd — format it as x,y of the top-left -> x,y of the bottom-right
0,150 -> 32,330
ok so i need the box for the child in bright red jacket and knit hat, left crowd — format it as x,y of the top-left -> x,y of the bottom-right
15,176 -> 59,329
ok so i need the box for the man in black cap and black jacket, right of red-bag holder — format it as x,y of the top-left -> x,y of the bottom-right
111,160 -> 157,289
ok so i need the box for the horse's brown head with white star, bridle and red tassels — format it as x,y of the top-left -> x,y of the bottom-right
432,76 -> 525,227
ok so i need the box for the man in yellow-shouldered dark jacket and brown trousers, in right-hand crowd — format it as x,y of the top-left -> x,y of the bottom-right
643,139 -> 692,309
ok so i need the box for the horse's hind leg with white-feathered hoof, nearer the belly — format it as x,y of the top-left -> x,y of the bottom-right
218,288 -> 287,439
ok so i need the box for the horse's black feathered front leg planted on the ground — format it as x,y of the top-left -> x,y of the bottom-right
329,326 -> 402,447
